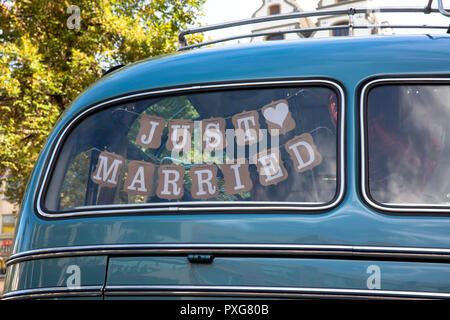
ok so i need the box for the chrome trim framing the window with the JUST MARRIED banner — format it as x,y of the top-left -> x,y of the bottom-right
35,78 -> 347,218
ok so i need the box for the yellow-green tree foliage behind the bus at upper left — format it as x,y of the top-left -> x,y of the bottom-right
0,0 -> 205,203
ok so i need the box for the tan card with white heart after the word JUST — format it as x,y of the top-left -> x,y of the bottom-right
262,100 -> 295,135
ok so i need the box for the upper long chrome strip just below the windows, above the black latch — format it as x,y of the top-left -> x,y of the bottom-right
6,243 -> 450,266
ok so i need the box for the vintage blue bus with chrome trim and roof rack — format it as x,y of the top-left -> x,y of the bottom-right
3,1 -> 450,300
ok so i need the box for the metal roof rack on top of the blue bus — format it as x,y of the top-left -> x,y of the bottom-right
178,0 -> 450,51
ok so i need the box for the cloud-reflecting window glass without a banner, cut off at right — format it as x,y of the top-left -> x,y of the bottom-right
366,84 -> 450,206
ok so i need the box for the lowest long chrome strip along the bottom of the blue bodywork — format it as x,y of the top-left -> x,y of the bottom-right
1,285 -> 450,300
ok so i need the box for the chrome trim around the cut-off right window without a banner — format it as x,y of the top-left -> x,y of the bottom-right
359,77 -> 450,213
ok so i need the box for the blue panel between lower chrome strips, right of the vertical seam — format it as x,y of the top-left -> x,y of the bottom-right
107,257 -> 450,292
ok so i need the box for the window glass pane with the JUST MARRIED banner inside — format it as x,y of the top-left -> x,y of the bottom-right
43,85 -> 341,213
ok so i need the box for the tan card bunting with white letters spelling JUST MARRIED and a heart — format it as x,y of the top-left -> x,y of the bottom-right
91,95 -> 322,200
